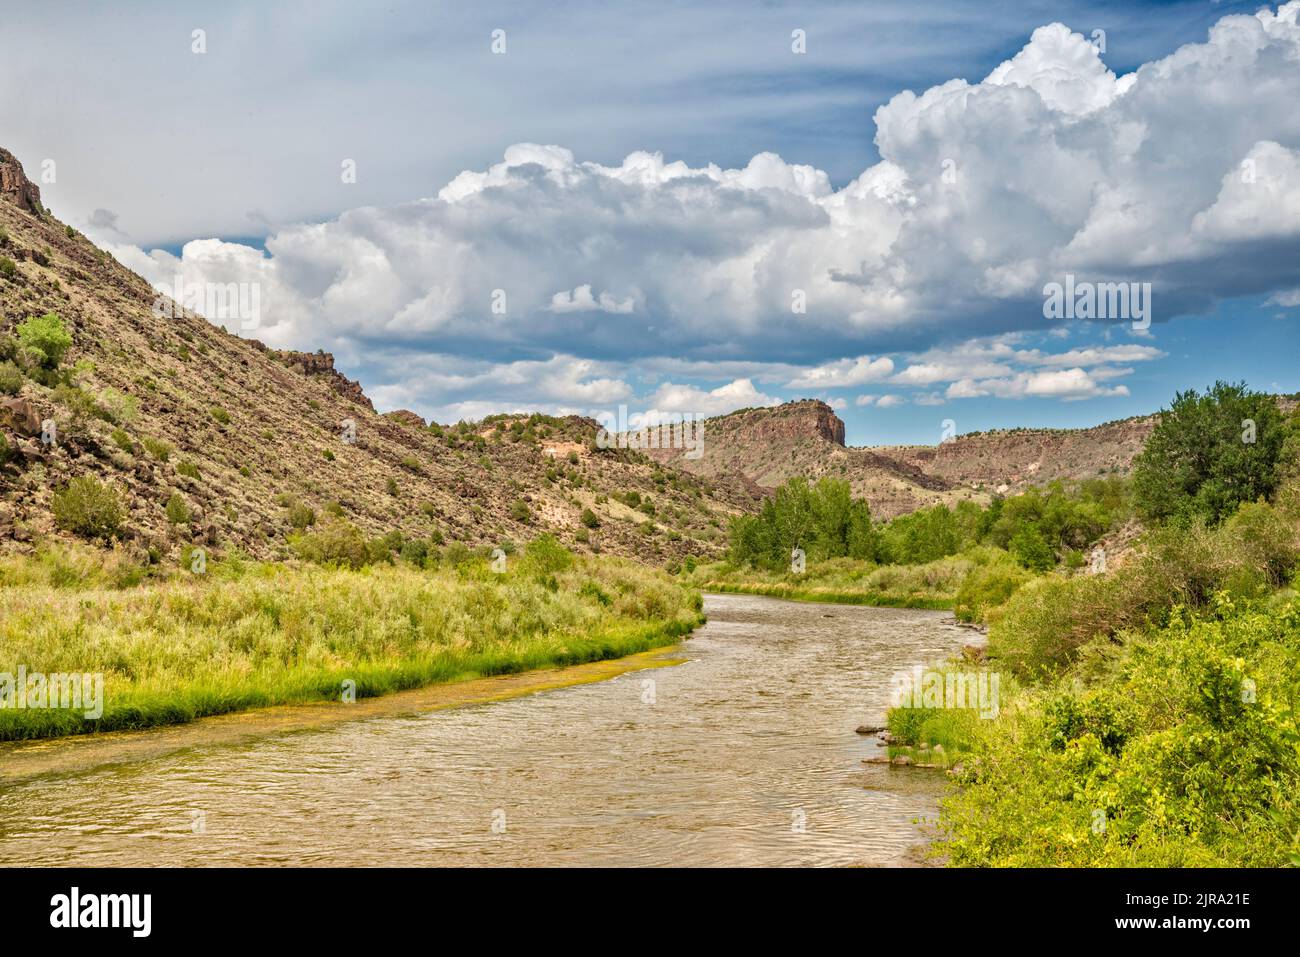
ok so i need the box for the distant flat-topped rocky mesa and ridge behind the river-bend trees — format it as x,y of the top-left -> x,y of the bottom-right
650,399 -> 1153,519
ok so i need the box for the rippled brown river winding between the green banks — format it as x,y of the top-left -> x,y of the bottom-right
0,596 -> 967,866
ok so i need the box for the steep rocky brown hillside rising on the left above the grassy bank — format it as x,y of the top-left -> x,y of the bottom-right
0,151 -> 755,562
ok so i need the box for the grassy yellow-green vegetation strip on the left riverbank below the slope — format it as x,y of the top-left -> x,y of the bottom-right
0,537 -> 702,740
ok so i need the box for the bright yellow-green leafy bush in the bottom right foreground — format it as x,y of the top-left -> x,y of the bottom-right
936,596 -> 1300,867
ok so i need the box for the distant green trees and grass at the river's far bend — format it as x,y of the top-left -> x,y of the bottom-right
686,477 -> 1132,613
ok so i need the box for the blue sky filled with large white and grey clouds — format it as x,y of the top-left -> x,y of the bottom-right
0,0 -> 1300,445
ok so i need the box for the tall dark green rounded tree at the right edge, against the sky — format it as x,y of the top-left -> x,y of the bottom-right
1134,382 -> 1286,524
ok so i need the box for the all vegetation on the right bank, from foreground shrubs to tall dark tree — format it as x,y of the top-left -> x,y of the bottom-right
930,386 -> 1300,866
